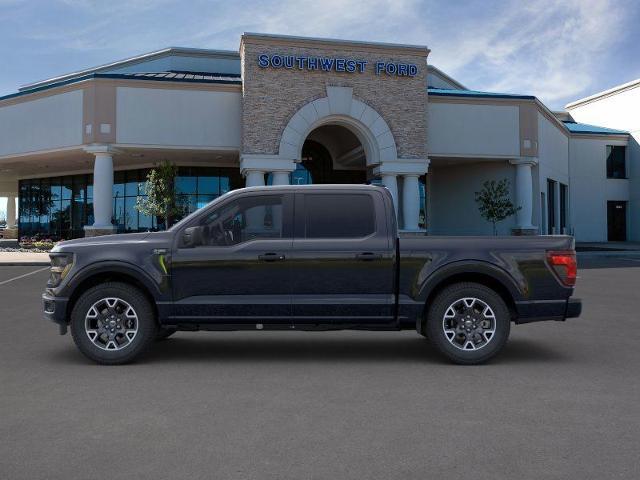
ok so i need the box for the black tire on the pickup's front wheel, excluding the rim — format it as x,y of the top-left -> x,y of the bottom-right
70,282 -> 158,365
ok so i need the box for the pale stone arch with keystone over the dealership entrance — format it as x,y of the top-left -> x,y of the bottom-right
278,86 -> 398,166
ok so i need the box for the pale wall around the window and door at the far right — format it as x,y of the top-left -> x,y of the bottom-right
569,136 -> 634,242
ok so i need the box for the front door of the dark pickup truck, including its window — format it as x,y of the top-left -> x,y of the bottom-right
171,194 -> 293,324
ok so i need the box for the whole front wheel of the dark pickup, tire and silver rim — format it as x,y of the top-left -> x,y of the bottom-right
70,282 -> 158,365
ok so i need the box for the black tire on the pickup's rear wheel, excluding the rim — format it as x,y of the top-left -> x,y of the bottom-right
425,282 -> 511,365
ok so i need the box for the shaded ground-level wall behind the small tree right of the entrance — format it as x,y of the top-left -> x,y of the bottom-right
427,161 -> 516,235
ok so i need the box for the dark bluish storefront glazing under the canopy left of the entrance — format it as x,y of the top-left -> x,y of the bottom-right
19,167 -> 242,240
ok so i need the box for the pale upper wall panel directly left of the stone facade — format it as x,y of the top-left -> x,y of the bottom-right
116,87 -> 242,149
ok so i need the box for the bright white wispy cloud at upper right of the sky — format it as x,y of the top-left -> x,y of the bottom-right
424,0 -> 629,108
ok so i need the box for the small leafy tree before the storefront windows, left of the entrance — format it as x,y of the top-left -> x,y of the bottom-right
136,160 -> 183,228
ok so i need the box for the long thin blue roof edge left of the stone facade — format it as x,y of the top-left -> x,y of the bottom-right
0,72 -> 242,100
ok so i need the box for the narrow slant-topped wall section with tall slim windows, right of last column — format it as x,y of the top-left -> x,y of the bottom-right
533,112 -> 572,234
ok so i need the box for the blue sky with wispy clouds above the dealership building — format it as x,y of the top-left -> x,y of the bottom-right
0,0 -> 640,217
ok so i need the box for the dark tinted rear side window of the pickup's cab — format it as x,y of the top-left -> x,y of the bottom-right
304,194 -> 375,238
